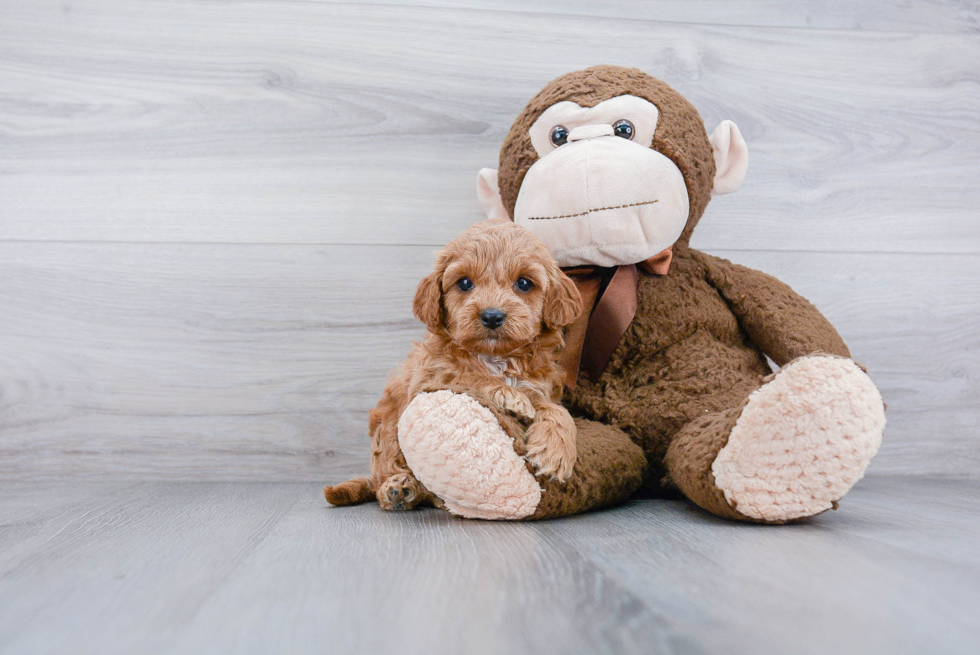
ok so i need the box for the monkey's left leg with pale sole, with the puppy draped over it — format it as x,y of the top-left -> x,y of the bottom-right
398,391 -> 646,520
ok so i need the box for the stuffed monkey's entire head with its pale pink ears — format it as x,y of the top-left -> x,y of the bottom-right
477,66 -> 748,266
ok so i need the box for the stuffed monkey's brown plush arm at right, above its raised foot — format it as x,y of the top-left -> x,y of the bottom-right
696,252 -> 851,366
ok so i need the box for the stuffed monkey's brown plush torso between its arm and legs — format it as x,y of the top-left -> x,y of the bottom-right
566,247 -> 771,480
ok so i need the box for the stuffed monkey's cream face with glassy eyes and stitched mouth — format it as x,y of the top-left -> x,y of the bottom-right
514,95 -> 689,266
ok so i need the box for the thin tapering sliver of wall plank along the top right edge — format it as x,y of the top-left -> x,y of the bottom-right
316,0 -> 980,34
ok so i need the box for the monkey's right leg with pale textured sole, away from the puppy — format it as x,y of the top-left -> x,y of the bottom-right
665,356 -> 885,523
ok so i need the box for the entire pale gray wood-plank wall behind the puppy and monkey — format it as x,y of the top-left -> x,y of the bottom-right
0,0 -> 980,480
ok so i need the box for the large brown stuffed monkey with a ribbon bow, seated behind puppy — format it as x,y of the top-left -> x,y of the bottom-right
399,66 -> 885,523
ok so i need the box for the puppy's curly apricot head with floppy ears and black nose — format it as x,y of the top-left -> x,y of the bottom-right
414,221 -> 582,355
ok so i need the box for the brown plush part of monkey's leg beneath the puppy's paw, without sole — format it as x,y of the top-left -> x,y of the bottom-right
525,419 -> 647,521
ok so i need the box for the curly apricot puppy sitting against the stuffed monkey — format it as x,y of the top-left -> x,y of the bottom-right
323,219 -> 582,510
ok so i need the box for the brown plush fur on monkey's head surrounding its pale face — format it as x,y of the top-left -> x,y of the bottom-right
498,66 -> 715,244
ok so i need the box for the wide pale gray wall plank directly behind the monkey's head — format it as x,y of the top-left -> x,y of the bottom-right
0,0 -> 980,253
